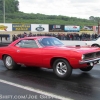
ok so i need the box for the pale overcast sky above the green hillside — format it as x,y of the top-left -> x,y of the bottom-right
18,0 -> 100,19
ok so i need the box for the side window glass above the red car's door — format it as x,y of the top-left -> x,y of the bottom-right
16,40 -> 38,48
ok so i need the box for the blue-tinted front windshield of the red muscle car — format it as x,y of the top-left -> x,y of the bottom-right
38,37 -> 64,46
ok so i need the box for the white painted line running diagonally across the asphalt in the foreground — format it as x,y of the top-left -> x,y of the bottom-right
0,79 -> 73,100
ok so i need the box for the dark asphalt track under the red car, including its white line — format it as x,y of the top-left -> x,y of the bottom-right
0,61 -> 100,100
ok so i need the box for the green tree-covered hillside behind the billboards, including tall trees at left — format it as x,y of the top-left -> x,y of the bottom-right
0,0 -> 100,26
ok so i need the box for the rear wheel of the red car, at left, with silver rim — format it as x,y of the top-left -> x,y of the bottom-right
3,55 -> 20,70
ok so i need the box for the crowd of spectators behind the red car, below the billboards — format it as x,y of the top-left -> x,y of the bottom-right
12,32 -> 99,41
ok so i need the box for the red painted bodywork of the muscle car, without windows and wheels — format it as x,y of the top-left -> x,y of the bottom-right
0,37 -> 100,68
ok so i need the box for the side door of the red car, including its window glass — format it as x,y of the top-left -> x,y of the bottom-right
14,39 -> 42,66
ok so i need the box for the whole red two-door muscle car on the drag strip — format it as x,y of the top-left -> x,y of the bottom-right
0,36 -> 100,79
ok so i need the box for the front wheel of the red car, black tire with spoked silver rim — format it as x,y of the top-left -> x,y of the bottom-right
53,59 -> 72,79
